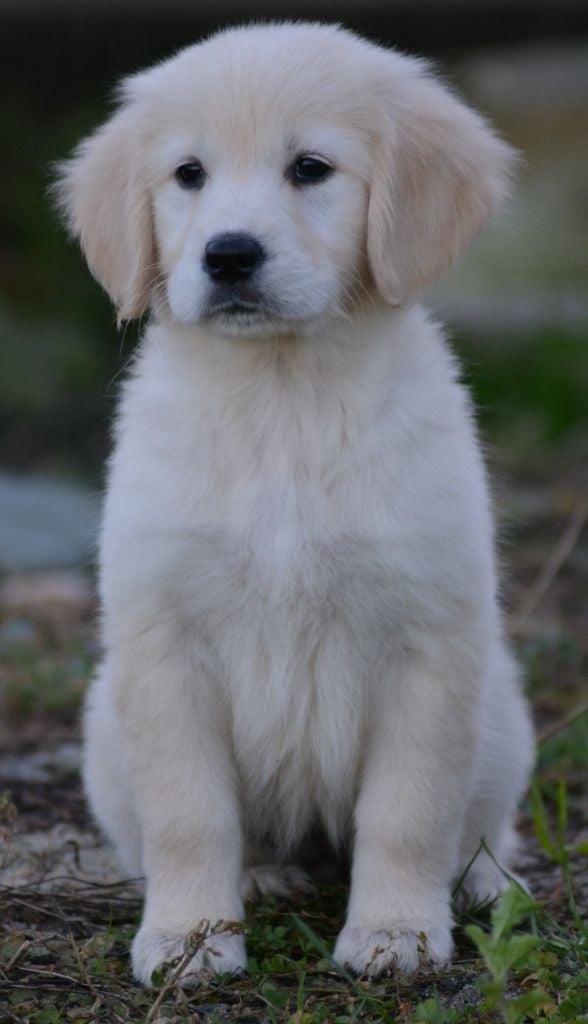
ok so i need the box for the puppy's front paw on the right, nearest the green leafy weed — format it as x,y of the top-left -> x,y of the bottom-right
334,925 -> 453,978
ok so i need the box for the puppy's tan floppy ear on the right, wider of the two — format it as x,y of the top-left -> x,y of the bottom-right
368,53 -> 514,305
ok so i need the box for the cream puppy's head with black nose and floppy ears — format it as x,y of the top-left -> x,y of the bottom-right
57,25 -> 511,335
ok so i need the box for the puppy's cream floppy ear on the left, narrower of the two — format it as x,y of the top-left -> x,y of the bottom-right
54,108 -> 155,323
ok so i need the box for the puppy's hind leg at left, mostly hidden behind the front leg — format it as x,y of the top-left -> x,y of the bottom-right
83,662 -> 142,878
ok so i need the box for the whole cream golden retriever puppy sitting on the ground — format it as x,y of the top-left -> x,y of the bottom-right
55,24 -> 532,984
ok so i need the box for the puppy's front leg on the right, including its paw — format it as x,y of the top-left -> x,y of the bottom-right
335,657 -> 478,976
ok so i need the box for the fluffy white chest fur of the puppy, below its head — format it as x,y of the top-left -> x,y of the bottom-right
102,310 -> 493,845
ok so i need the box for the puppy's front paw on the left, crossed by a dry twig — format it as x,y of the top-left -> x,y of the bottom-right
132,925 -> 247,988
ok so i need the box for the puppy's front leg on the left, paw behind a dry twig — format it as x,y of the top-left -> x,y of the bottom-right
117,636 -> 246,984
